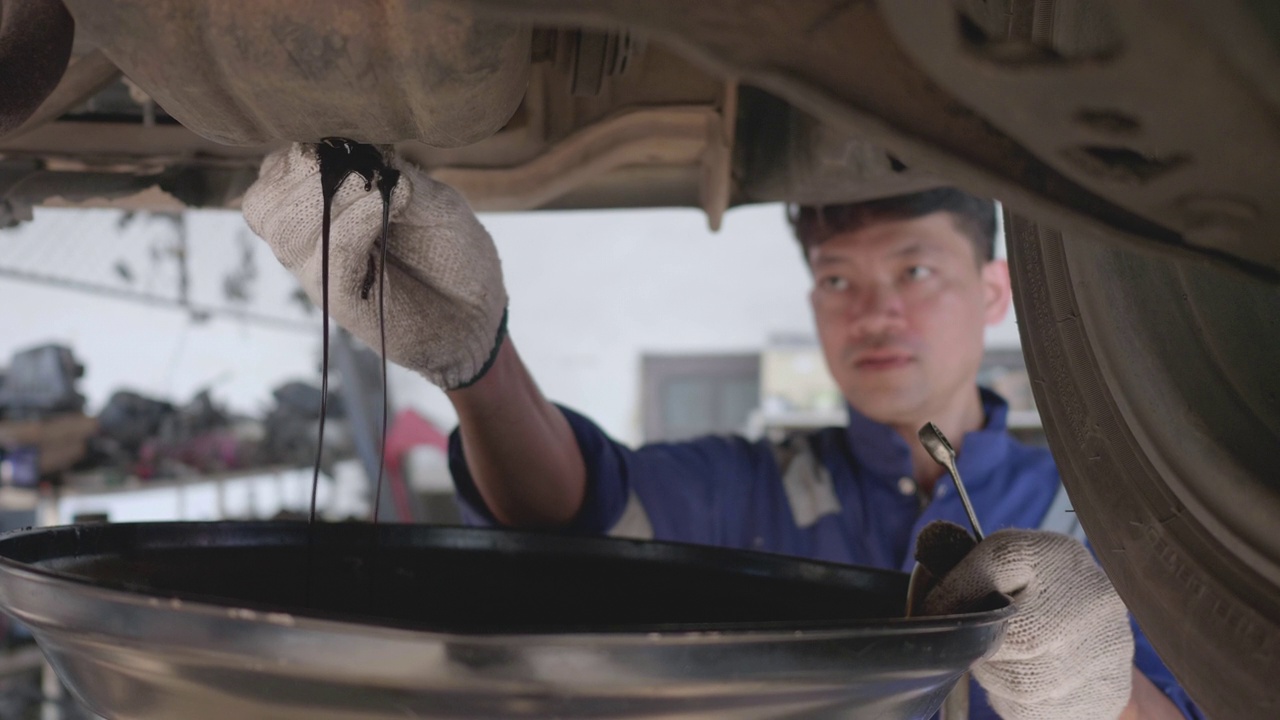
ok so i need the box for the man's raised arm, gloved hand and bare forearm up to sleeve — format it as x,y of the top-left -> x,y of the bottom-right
243,143 -> 586,527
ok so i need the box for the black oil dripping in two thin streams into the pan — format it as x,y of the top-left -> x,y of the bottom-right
306,137 -> 399,605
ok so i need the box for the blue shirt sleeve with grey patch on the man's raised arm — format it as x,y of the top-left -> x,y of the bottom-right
449,407 -> 777,544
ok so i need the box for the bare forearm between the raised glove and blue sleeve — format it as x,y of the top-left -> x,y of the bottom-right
448,337 -> 586,528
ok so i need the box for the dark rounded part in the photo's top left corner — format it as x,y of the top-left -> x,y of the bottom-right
0,0 -> 76,136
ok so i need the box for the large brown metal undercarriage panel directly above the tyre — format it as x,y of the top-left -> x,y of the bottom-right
466,0 -> 1280,282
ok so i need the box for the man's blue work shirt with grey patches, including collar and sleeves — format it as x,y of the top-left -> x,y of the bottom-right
449,389 -> 1202,720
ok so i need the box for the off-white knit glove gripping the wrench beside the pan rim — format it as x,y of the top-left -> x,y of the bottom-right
916,520 -> 1133,720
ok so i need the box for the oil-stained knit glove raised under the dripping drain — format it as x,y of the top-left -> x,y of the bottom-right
243,143 -> 507,389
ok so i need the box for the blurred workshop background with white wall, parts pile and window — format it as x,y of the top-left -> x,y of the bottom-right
0,205 -> 1042,717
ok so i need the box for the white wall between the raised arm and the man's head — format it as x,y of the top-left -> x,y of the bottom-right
394,205 -> 813,442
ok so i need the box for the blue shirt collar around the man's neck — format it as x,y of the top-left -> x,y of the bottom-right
846,387 -> 1010,484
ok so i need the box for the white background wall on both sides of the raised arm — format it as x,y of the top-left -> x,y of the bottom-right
0,205 -> 1018,442
